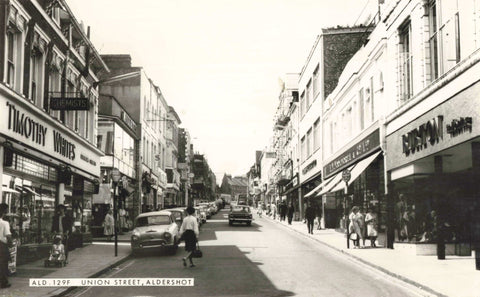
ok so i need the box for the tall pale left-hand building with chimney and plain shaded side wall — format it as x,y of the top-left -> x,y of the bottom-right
100,55 -> 169,213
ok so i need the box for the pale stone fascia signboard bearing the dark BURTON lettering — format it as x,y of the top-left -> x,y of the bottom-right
385,83 -> 480,170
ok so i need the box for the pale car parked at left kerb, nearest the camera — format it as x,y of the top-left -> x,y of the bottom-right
131,210 -> 180,255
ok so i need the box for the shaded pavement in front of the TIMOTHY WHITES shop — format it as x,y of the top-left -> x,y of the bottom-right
0,233 -> 130,297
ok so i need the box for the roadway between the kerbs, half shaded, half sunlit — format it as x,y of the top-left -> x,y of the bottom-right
65,210 -> 422,297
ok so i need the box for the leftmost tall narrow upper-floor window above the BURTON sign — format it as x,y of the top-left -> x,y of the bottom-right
398,21 -> 413,100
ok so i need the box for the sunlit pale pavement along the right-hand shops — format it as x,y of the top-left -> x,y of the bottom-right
263,215 -> 480,297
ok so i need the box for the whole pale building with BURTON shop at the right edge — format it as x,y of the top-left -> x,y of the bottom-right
382,1 -> 480,254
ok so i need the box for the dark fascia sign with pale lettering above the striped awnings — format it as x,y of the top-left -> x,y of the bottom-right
323,129 -> 380,177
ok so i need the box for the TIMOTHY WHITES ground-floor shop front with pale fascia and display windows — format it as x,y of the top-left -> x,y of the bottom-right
0,95 -> 102,260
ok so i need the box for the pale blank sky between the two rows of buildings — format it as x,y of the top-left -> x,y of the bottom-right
67,0 -> 376,183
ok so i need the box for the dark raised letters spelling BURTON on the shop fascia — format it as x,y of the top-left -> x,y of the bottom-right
402,115 -> 443,156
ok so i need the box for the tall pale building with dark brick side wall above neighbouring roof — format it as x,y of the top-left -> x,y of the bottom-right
296,26 -> 372,220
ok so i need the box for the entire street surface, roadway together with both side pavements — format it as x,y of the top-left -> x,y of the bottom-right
0,210 -> 480,297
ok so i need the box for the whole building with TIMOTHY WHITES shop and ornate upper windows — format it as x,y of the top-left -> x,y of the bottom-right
0,0 -> 108,260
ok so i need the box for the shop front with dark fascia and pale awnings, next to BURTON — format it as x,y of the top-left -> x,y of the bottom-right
315,125 -> 386,240
